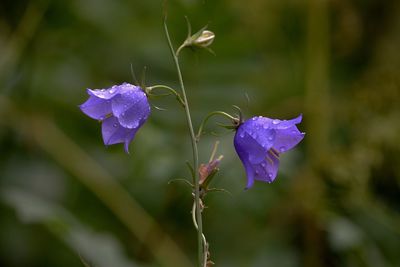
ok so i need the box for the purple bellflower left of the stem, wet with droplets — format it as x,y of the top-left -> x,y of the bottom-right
79,83 -> 150,153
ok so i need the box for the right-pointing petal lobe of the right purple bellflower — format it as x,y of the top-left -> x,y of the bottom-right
273,126 -> 305,153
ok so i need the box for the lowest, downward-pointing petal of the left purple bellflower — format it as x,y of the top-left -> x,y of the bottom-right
101,116 -> 137,150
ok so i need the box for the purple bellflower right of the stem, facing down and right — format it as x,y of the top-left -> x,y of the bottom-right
234,115 -> 304,189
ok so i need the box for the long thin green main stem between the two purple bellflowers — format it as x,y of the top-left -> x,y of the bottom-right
164,18 -> 206,267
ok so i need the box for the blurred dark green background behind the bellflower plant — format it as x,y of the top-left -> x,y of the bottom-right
0,0 -> 400,267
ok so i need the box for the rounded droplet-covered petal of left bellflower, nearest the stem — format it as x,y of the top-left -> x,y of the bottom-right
111,87 -> 150,129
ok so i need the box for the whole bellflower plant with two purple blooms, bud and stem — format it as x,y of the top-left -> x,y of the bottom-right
79,13 -> 304,267
